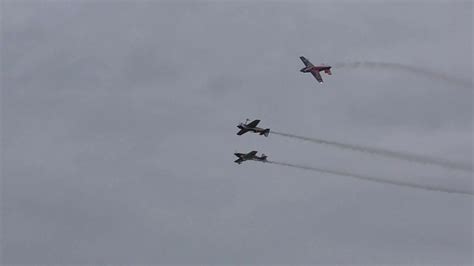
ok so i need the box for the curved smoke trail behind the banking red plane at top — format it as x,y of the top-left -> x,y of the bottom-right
333,61 -> 472,88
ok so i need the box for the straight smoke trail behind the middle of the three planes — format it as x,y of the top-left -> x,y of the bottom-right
271,131 -> 472,172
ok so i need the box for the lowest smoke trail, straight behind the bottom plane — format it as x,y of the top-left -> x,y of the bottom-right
268,161 -> 474,196
